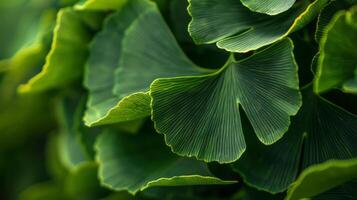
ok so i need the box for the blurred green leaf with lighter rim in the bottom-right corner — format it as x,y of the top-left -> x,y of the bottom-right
286,159 -> 357,200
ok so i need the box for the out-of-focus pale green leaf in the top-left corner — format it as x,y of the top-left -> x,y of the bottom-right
0,0 -> 55,60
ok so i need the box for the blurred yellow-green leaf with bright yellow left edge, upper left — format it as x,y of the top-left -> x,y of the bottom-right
19,8 -> 102,92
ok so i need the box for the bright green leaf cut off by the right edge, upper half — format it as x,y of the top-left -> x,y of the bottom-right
314,6 -> 357,93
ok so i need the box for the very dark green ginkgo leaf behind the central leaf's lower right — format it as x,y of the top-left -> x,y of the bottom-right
232,86 -> 357,193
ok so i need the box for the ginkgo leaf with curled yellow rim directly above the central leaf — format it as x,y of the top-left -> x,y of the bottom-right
188,0 -> 328,53
